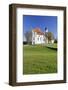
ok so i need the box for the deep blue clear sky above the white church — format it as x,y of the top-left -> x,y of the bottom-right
23,15 -> 57,38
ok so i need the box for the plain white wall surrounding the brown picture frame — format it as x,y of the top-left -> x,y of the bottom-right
0,0 -> 68,90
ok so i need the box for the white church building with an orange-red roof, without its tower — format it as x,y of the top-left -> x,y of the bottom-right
32,28 -> 48,45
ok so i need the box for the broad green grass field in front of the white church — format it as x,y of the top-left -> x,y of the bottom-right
23,45 -> 57,74
